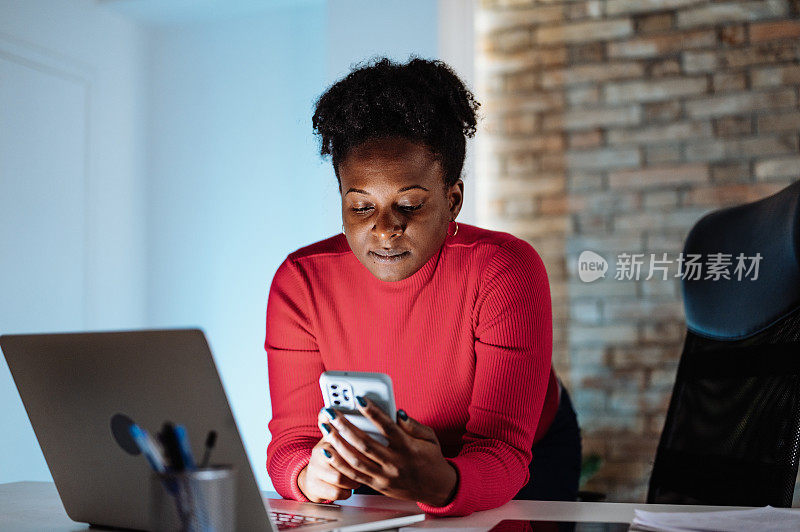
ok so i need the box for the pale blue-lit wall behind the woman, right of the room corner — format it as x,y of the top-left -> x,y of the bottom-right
147,0 -> 437,488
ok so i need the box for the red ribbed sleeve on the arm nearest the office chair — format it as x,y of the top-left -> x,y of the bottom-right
419,239 -> 552,516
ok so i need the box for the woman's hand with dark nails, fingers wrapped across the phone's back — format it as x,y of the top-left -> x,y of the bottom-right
320,399 -> 458,506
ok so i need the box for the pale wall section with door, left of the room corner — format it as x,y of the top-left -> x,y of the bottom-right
0,0 -> 145,482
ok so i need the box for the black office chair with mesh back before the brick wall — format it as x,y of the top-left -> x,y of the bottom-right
647,181 -> 800,507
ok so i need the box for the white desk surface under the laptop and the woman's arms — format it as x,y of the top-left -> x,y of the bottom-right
0,482 -> 752,532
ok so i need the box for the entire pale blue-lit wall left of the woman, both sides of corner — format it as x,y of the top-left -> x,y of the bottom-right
0,0 -> 450,489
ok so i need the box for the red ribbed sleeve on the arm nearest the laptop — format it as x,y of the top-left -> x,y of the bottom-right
264,259 -> 324,501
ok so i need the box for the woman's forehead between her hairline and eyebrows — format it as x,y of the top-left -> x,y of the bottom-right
339,138 -> 444,188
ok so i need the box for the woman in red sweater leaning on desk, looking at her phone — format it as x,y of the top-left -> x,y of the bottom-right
265,59 -> 580,515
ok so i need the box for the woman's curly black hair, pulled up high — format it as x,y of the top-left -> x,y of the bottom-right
312,57 -> 480,187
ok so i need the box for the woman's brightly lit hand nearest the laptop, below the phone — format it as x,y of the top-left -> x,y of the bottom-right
297,434 -> 361,502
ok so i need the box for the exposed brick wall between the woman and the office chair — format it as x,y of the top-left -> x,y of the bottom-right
476,0 -> 800,501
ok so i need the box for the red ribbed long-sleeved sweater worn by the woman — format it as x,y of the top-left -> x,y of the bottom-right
265,224 -> 558,515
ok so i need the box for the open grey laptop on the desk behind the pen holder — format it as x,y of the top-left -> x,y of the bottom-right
0,329 -> 425,532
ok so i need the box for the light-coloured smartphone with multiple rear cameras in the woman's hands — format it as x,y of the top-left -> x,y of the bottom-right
319,371 -> 397,445
